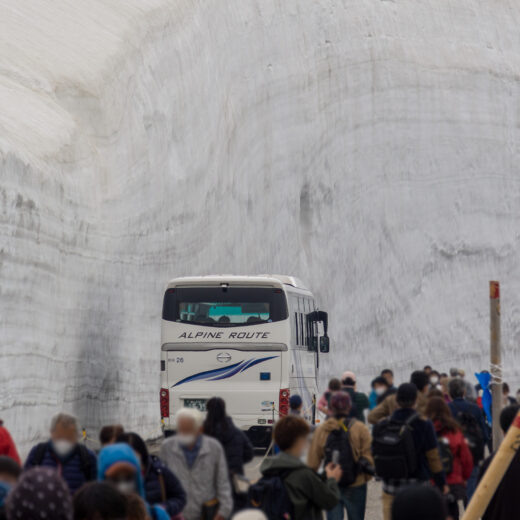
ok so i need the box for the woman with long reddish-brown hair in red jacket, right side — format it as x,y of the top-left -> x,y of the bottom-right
426,397 -> 473,520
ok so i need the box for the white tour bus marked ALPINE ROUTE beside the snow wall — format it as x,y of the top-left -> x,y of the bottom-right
160,275 -> 329,446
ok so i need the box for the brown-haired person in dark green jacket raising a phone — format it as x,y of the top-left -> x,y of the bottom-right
260,415 -> 341,520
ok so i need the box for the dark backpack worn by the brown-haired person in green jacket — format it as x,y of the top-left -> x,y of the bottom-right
248,470 -> 294,520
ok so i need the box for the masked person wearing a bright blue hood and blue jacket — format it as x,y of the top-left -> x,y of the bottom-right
98,443 -> 170,520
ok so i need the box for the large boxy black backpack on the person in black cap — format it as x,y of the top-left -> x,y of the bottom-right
372,413 -> 419,480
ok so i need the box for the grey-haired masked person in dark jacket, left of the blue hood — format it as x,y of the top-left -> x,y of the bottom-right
24,413 -> 97,494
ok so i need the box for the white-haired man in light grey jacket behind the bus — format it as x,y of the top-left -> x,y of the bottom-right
160,408 -> 233,520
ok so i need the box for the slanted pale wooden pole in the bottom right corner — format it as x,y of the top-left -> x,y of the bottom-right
462,412 -> 520,520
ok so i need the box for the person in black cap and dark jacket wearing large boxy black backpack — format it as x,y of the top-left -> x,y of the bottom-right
372,382 -> 449,520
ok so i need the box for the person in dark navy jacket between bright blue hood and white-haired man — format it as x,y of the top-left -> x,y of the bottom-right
117,432 -> 186,517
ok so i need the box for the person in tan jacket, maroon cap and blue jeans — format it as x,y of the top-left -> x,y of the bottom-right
307,392 -> 374,520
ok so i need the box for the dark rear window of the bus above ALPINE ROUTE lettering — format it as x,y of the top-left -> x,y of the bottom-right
163,287 -> 287,327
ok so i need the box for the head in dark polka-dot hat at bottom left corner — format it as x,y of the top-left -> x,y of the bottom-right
5,467 -> 73,520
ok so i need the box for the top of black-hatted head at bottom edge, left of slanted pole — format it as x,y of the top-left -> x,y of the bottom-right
392,485 -> 447,520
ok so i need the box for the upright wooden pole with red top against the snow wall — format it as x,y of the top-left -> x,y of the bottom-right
489,282 -> 503,450
